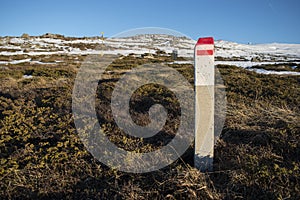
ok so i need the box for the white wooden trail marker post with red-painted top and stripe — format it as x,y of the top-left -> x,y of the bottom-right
194,37 -> 215,171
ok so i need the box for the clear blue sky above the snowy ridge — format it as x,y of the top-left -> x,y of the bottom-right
0,0 -> 300,43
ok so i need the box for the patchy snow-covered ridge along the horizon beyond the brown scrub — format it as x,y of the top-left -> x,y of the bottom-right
0,35 -> 300,75
